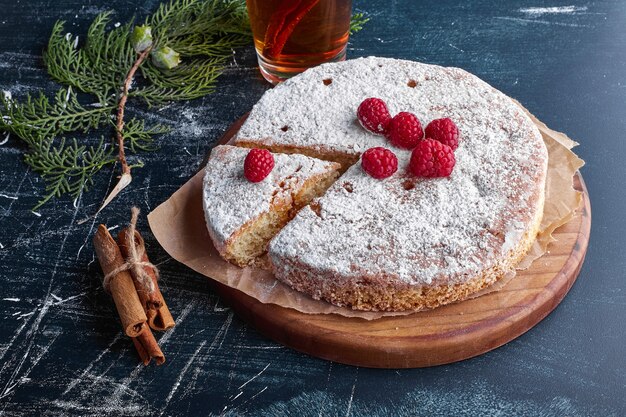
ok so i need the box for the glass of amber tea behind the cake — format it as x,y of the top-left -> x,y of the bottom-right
246,0 -> 352,84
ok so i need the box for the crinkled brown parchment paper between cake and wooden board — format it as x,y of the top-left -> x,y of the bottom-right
148,103 -> 584,320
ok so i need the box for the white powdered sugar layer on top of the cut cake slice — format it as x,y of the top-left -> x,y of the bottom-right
203,145 -> 332,249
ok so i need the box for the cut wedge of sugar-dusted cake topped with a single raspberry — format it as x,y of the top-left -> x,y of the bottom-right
203,146 -> 339,267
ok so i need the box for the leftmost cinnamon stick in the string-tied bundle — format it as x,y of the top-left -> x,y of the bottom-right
93,224 -> 148,337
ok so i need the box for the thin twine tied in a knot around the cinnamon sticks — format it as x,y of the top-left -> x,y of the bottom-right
102,207 -> 159,294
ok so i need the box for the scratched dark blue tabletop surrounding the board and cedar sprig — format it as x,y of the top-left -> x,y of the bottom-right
0,0 -> 626,416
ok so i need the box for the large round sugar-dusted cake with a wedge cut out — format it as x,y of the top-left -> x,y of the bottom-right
227,57 -> 548,311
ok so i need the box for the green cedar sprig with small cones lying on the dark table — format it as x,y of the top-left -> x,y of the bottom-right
0,0 -> 369,209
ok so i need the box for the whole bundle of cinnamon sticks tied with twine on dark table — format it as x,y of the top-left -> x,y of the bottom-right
93,207 -> 175,365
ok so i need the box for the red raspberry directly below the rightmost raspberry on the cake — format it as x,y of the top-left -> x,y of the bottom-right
409,139 -> 456,177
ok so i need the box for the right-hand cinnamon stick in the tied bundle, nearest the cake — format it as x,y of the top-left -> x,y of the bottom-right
117,227 -> 176,331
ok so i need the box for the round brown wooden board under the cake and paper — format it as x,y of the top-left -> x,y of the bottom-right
212,116 -> 591,368
